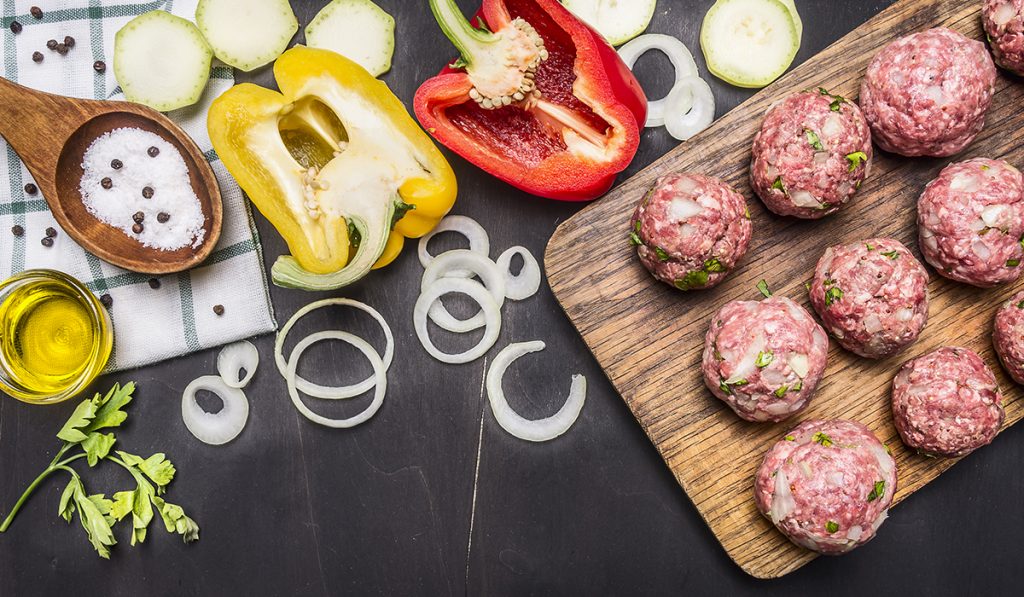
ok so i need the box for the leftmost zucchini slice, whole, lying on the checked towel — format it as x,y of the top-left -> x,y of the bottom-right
114,10 -> 213,112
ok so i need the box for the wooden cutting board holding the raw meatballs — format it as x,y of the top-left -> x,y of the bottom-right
545,0 -> 1024,579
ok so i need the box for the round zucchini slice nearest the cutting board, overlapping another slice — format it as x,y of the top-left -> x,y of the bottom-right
700,0 -> 800,88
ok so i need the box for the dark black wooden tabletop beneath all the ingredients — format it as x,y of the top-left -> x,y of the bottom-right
0,0 -> 1024,597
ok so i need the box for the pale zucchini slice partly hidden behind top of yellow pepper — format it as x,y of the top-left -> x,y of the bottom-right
306,0 -> 394,77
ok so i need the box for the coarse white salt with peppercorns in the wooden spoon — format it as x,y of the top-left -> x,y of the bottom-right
79,128 -> 206,251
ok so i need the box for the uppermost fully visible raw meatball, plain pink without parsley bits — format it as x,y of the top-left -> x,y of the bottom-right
860,28 -> 995,157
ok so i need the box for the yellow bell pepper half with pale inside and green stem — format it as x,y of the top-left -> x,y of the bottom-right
207,46 -> 457,290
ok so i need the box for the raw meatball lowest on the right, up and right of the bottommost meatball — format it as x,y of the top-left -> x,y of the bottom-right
893,347 -> 1004,457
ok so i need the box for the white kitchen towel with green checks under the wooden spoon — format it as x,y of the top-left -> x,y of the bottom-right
0,0 -> 276,371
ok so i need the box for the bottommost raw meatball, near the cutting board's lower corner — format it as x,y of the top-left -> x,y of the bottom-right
754,420 -> 896,555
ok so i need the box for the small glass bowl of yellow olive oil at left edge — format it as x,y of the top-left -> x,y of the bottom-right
0,269 -> 114,404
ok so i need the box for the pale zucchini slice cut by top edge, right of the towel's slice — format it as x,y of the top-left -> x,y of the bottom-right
196,0 -> 299,71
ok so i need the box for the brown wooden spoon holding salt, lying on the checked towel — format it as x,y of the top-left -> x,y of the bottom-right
0,77 -> 223,274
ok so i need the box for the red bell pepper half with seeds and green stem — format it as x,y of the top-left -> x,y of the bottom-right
415,0 -> 647,201
